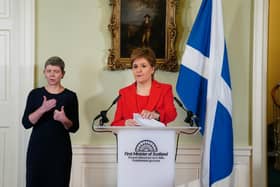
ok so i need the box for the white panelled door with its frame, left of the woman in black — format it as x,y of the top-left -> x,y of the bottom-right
0,0 -> 35,187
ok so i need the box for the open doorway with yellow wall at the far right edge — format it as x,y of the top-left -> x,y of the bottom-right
267,0 -> 280,187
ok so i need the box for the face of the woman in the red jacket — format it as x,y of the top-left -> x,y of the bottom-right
132,58 -> 155,83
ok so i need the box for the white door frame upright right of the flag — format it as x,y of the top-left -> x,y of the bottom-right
251,0 -> 269,186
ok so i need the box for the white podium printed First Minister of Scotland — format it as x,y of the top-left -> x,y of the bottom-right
93,126 -> 199,187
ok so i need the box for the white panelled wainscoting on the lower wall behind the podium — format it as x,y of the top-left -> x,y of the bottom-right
71,145 -> 252,187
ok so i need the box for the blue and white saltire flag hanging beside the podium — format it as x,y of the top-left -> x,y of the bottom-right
176,0 -> 233,187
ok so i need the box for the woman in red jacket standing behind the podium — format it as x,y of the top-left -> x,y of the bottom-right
112,48 -> 177,126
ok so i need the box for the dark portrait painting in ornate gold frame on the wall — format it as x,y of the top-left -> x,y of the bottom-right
107,0 -> 178,72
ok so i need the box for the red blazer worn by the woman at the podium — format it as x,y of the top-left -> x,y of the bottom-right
112,80 -> 177,126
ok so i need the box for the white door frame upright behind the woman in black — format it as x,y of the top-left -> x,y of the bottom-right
17,0 -> 35,187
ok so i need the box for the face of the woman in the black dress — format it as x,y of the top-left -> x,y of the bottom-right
44,65 -> 64,85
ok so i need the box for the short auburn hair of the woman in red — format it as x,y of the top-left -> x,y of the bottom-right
130,47 -> 156,67
